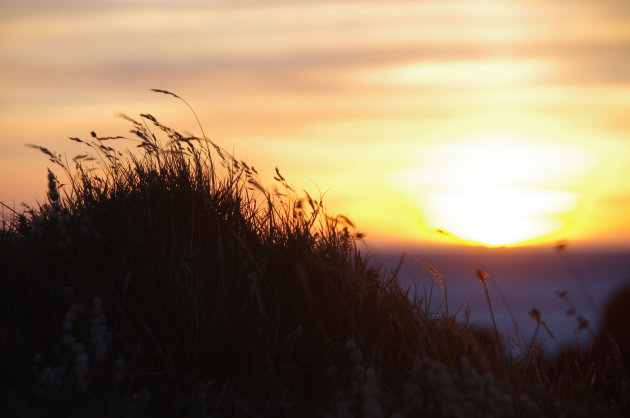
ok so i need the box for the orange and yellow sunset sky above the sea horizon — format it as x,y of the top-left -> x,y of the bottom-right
0,0 -> 630,248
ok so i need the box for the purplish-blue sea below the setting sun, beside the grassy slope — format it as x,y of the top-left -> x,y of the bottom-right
367,247 -> 630,355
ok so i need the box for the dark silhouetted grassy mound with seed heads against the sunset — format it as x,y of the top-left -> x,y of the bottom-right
0,90 -> 628,417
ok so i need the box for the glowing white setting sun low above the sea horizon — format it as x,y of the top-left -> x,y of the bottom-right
394,132 -> 592,246
